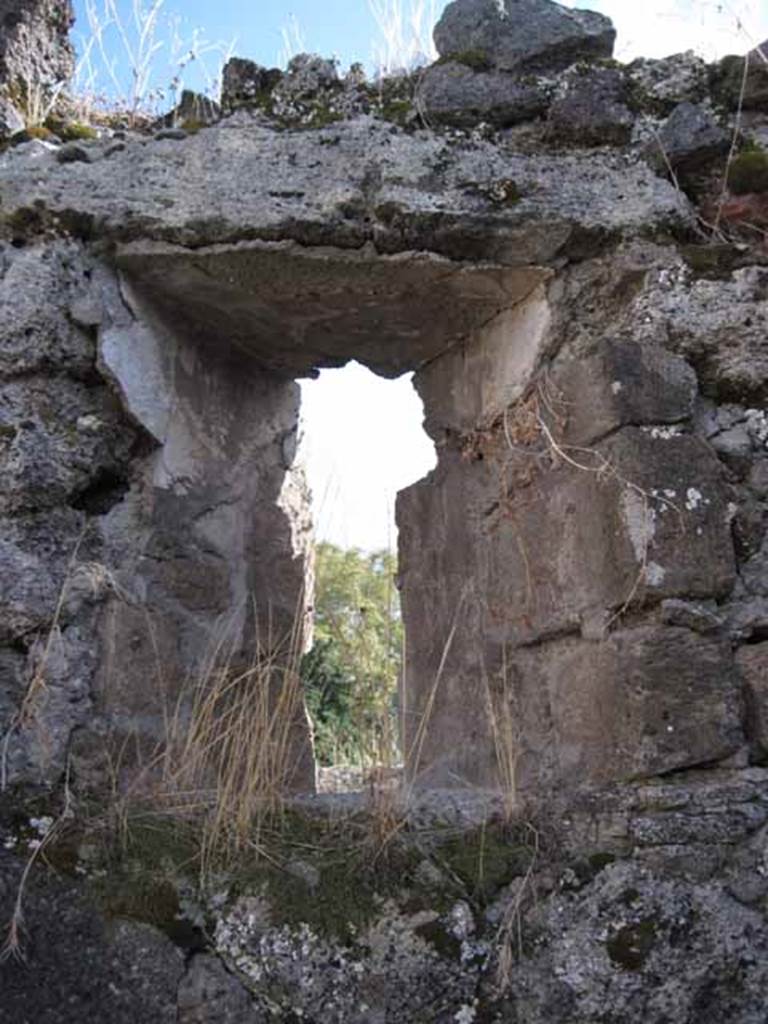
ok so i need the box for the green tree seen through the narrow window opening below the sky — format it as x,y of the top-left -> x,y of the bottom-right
302,543 -> 402,764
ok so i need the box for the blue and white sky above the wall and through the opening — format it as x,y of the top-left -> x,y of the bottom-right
70,0 -> 768,549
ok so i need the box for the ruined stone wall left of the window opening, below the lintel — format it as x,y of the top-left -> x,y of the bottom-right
0,241 -> 313,787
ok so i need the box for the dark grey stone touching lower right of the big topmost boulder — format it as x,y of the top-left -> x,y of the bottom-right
549,68 -> 634,146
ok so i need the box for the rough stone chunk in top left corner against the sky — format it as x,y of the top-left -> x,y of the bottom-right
0,0 -> 75,96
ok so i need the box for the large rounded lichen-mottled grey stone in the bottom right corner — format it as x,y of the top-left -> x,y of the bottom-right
508,862 -> 768,1024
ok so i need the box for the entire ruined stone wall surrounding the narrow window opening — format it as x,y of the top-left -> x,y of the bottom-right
0,0 -> 768,1024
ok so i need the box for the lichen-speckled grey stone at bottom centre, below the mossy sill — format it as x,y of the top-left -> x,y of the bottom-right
215,895 -> 484,1024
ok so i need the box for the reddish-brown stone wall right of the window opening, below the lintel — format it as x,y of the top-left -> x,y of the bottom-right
398,246 -> 765,795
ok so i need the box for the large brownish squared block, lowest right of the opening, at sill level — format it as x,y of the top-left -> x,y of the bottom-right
512,627 -> 743,792
